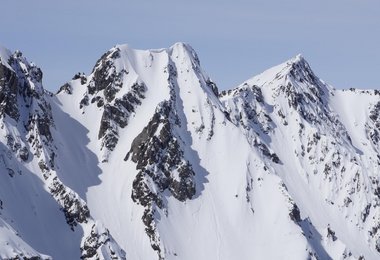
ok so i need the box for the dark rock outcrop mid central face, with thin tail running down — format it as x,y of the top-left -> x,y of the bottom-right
125,101 -> 195,258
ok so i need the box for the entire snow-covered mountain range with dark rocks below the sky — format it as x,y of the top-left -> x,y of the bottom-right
0,43 -> 380,259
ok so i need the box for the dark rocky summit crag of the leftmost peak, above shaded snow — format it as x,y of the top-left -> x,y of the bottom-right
0,52 -> 54,172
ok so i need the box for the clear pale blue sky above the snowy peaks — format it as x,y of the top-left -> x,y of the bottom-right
0,0 -> 380,91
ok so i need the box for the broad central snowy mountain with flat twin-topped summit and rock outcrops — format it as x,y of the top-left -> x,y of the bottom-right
52,43 -> 317,259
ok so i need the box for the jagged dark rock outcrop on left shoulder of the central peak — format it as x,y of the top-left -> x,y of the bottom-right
75,47 -> 147,161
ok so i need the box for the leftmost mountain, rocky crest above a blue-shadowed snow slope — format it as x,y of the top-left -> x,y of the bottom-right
0,46 -> 124,259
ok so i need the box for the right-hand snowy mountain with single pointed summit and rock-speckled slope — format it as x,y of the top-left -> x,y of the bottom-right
221,56 -> 380,259
